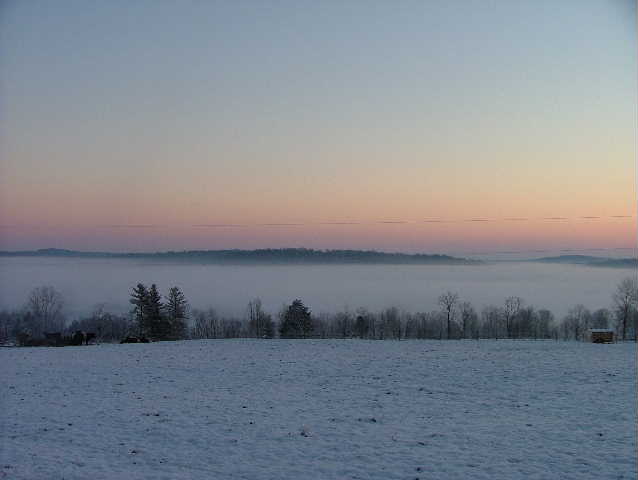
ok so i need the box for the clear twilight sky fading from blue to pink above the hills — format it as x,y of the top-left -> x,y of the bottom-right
0,0 -> 638,253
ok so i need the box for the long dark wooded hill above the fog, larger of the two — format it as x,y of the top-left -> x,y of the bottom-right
0,248 -> 483,265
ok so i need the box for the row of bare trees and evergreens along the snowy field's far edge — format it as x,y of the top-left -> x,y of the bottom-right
0,278 -> 638,343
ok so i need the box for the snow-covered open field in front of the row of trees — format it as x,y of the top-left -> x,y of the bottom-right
0,340 -> 636,480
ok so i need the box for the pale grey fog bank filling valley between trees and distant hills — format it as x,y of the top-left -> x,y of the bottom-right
0,257 -> 635,318
